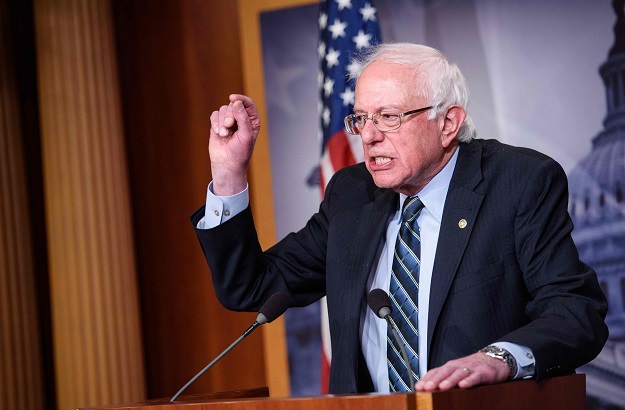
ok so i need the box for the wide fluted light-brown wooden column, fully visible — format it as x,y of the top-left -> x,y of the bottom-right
34,0 -> 145,409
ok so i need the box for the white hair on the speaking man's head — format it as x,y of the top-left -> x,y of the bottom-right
349,43 -> 476,142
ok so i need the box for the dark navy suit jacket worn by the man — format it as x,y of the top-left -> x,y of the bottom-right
192,140 -> 608,393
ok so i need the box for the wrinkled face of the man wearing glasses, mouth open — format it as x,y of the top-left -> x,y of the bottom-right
354,61 -> 453,195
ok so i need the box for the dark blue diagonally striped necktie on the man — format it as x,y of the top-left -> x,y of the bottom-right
386,196 -> 423,392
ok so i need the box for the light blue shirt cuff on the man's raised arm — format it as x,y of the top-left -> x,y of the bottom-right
197,181 -> 250,229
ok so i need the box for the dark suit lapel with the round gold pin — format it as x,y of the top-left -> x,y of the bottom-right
428,141 -> 484,346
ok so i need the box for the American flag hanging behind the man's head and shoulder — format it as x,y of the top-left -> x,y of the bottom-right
318,0 -> 380,393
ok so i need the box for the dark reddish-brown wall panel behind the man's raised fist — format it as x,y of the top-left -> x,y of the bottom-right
115,0 -> 284,397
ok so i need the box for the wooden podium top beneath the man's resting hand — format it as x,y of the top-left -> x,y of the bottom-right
79,374 -> 586,410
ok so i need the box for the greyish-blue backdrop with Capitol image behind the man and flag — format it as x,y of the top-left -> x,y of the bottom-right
261,0 -> 625,408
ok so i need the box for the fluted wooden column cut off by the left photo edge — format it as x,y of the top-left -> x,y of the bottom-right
0,0 -> 44,410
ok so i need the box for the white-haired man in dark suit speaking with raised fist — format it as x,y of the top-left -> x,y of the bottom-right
192,44 -> 608,393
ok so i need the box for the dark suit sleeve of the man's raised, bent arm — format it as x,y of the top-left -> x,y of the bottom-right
191,172 -> 344,311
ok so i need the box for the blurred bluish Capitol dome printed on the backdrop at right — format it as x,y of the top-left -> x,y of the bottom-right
568,0 -> 625,408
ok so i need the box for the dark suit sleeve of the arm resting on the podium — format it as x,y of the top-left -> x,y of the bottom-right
501,159 -> 608,380
